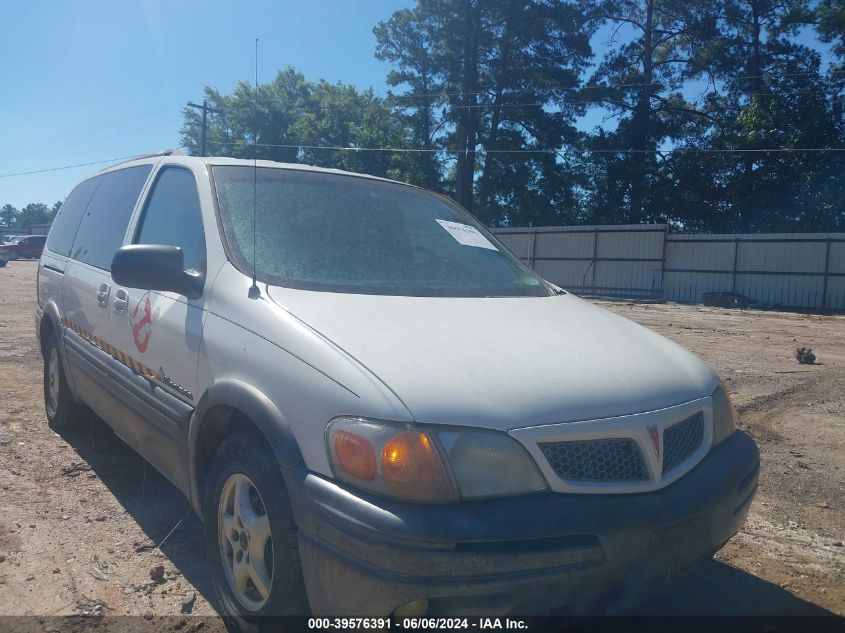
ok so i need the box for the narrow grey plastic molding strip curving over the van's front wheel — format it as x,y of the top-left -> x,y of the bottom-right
188,379 -> 305,516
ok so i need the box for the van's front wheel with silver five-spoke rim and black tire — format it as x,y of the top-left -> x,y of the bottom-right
203,434 -> 310,631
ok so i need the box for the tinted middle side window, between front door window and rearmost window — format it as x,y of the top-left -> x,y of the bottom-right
71,165 -> 152,270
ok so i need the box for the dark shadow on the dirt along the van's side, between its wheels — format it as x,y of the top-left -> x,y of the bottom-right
55,415 -> 214,610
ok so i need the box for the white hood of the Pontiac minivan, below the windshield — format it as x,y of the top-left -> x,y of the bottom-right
269,287 -> 718,431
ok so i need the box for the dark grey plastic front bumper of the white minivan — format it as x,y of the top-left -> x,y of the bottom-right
287,431 -> 759,616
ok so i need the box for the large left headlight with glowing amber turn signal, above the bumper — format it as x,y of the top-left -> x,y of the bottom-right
326,417 -> 546,502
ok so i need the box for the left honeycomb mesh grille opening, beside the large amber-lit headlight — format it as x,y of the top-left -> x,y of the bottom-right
539,438 -> 649,482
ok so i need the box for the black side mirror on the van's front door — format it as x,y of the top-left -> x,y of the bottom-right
111,244 -> 205,299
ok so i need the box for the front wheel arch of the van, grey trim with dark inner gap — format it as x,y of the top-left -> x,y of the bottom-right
188,379 -> 305,518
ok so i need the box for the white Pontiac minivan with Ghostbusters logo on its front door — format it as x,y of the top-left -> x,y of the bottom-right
35,154 -> 759,624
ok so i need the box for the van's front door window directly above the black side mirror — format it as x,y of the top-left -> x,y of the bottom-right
136,167 -> 205,271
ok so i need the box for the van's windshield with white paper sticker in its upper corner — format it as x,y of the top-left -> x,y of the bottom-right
213,166 -> 551,297
